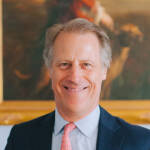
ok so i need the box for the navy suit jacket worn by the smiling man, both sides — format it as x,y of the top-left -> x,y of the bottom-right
5,108 -> 150,150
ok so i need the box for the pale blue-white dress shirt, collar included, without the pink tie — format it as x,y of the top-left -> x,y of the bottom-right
52,106 -> 100,150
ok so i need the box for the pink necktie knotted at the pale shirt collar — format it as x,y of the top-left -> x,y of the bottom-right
61,122 -> 76,150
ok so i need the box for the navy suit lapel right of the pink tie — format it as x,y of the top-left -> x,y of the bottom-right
96,108 -> 124,150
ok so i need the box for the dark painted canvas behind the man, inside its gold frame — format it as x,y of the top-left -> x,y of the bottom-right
2,0 -> 150,101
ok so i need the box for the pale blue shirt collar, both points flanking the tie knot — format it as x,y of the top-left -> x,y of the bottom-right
54,106 -> 100,137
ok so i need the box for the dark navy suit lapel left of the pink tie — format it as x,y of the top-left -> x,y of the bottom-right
30,112 -> 55,150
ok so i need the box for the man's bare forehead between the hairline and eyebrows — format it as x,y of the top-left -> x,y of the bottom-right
53,32 -> 100,59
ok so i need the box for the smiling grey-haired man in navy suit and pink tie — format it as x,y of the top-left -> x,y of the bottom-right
5,18 -> 150,150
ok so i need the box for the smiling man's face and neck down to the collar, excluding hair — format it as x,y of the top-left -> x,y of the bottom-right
50,32 -> 106,118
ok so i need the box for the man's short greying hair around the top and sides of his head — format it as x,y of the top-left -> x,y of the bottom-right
43,18 -> 112,68
